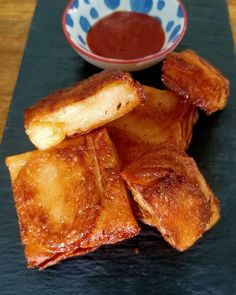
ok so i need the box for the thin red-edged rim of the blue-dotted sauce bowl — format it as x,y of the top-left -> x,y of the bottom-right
62,0 -> 188,64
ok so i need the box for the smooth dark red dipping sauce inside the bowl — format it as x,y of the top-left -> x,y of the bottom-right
87,11 -> 165,59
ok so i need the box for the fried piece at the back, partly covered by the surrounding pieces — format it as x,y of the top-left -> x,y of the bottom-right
108,86 -> 198,164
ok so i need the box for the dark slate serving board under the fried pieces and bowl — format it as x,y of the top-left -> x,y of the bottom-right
0,0 -> 236,295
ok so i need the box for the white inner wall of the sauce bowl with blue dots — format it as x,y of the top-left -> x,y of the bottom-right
65,0 -> 185,51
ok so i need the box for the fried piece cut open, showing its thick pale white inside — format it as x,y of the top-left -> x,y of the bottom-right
24,70 -> 144,149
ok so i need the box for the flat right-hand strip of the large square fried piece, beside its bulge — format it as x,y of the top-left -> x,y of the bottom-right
81,133 -> 139,248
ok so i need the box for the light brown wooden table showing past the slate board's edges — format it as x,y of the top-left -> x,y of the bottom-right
0,0 -> 236,142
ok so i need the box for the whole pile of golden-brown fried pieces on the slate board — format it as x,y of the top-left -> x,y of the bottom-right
6,50 -> 229,269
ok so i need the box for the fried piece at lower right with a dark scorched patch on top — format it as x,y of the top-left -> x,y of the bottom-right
121,144 -> 220,251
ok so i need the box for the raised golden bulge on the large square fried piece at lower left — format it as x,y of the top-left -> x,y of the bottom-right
6,138 -> 101,267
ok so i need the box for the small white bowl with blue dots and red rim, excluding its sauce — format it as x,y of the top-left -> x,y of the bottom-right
62,0 -> 187,71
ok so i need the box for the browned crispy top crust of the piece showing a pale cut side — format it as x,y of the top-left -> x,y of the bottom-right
24,70 -> 145,128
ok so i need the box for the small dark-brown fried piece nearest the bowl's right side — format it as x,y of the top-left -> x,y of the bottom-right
162,50 -> 229,115
